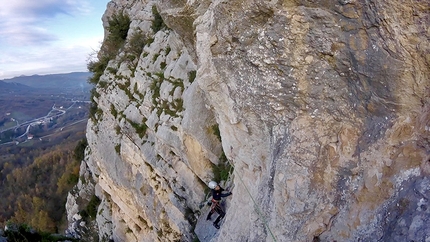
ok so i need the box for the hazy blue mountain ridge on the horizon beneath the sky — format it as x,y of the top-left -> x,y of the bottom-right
1,72 -> 92,89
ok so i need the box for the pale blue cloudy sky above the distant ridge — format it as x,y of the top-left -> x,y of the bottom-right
0,0 -> 109,80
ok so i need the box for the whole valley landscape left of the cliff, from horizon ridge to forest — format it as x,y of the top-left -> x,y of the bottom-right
0,73 -> 92,233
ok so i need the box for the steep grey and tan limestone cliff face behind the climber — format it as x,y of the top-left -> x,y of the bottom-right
68,0 -> 430,241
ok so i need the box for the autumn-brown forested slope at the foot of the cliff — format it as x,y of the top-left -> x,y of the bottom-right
0,140 -> 86,233
